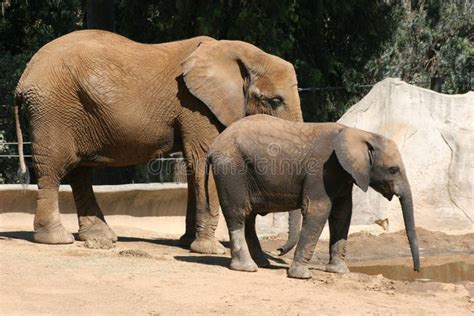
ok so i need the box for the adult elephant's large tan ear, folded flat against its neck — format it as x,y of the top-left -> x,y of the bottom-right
182,41 -> 248,126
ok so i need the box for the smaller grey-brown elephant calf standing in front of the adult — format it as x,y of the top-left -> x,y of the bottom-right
207,115 -> 419,279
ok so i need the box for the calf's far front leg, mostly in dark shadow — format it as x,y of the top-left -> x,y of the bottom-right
326,192 -> 352,273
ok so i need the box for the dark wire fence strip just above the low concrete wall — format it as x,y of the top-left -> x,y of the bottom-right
0,142 -> 187,185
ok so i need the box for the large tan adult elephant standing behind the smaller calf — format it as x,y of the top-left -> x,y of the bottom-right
15,30 -> 302,253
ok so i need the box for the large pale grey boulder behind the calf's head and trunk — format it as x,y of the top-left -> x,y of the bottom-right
339,79 -> 474,233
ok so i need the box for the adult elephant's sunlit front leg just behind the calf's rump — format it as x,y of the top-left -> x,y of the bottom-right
191,159 -> 225,254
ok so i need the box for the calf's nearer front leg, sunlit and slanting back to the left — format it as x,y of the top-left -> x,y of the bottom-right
288,197 -> 331,279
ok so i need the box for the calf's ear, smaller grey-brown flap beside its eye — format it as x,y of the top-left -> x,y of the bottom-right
333,128 -> 371,192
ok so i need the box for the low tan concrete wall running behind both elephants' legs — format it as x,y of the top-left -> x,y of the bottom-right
0,183 -> 288,239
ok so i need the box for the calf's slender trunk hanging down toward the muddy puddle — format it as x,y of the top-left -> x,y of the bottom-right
399,185 -> 420,272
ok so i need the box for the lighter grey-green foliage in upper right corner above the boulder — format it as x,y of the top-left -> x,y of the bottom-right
366,0 -> 474,94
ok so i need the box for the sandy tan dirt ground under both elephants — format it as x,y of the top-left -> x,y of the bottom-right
0,217 -> 474,315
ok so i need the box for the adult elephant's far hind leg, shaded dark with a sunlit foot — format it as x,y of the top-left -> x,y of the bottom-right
69,167 -> 117,242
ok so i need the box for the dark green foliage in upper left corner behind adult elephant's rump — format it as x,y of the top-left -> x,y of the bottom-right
0,0 -> 82,104
